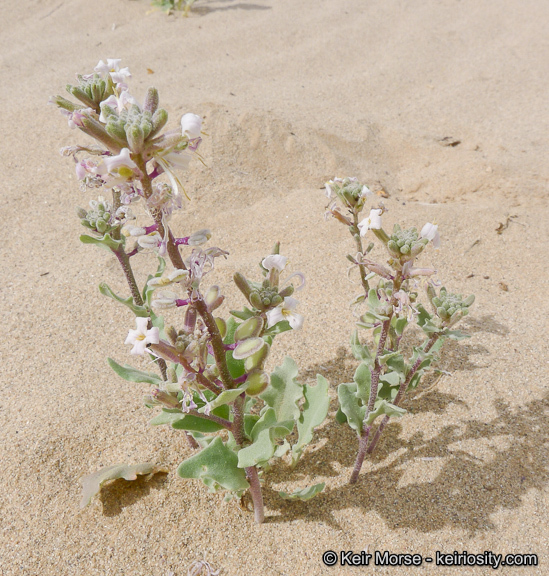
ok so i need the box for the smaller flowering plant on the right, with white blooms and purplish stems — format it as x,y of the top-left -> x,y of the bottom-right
325,178 -> 475,484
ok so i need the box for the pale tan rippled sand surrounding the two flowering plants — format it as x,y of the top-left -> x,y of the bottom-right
0,0 -> 549,576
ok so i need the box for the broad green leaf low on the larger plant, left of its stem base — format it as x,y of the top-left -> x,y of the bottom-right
177,436 -> 250,492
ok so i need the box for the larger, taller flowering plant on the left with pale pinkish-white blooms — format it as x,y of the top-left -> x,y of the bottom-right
52,59 -> 328,522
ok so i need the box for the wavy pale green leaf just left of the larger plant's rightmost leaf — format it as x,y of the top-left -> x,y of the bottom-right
259,356 -> 303,422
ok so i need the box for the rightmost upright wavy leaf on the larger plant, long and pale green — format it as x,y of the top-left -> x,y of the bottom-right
292,374 -> 330,466
